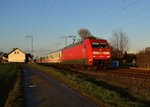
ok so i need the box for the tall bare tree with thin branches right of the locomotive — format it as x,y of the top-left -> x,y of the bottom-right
110,29 -> 129,58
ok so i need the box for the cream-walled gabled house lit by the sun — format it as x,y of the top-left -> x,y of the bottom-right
8,48 -> 26,62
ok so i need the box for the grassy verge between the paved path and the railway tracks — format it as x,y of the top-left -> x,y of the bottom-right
32,64 -> 150,107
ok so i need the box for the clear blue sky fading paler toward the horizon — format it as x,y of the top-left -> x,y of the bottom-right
0,0 -> 150,56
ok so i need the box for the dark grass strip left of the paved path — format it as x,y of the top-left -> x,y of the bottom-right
0,64 -> 23,107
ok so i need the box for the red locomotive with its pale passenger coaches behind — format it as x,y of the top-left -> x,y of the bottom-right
36,37 -> 111,67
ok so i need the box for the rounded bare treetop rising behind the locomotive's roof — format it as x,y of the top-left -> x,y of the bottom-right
78,28 -> 93,40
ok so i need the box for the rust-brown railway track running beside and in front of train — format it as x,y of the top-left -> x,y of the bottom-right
39,64 -> 150,79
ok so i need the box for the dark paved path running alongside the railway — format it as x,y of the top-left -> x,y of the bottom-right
23,65 -> 97,107
